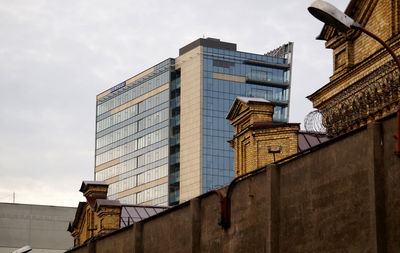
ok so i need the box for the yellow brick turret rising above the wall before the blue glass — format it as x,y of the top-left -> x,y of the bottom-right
226,97 -> 300,177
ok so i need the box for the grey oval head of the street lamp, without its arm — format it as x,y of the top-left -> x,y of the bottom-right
308,0 -> 360,32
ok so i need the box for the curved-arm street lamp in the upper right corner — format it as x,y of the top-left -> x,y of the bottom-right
308,0 -> 400,156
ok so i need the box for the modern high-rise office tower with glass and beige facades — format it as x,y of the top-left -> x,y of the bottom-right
95,38 -> 293,205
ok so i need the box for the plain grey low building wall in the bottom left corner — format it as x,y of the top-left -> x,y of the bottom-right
0,203 -> 76,253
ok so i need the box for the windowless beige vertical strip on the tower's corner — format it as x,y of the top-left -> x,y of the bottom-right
175,46 -> 203,203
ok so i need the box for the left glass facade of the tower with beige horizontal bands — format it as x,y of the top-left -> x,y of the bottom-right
95,59 -> 173,208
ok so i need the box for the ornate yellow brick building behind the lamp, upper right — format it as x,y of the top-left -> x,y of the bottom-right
308,0 -> 400,137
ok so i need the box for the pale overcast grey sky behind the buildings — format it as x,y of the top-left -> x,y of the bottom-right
0,0 -> 349,206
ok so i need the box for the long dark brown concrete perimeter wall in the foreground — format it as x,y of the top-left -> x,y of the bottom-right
66,116 -> 400,253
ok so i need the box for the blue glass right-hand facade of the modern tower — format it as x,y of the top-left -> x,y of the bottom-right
202,47 -> 290,193
